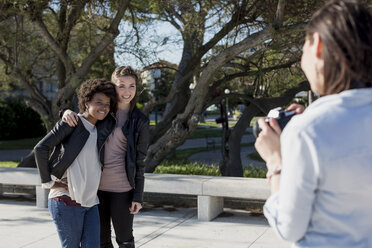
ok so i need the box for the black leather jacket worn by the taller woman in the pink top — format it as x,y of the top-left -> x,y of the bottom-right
96,108 -> 149,203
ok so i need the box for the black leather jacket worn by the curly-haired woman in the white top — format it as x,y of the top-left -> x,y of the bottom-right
34,117 -> 107,183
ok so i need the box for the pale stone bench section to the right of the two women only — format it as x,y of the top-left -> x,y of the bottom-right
145,174 -> 270,221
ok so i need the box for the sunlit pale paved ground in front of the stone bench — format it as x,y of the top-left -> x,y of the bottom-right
0,199 -> 290,248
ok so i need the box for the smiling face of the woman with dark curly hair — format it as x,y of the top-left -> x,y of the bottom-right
83,93 -> 110,125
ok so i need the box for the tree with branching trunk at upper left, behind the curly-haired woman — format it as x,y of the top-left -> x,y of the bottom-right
0,0 -> 129,130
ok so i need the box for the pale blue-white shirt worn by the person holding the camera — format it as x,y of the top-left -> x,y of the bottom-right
264,88 -> 372,248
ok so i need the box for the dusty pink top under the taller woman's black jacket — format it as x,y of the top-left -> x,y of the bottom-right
99,110 -> 132,192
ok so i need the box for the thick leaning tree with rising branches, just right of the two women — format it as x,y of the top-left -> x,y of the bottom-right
138,0 -> 320,172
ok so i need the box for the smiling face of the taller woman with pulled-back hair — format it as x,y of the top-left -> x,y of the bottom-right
114,76 -> 137,108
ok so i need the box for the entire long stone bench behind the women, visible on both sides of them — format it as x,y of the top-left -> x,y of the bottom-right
0,167 -> 270,221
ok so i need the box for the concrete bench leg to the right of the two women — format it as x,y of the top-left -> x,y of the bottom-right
198,195 -> 223,221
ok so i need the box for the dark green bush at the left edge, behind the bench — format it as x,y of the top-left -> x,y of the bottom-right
0,99 -> 46,140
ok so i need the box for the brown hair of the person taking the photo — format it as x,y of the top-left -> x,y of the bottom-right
306,0 -> 372,95
